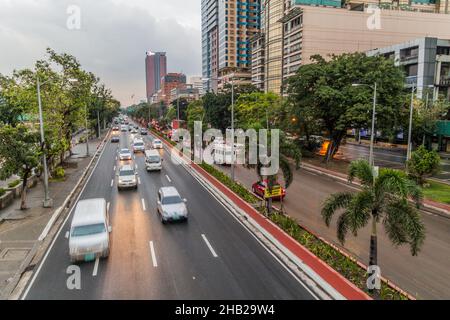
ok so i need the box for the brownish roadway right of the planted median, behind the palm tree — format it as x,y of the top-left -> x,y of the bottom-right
217,162 -> 450,299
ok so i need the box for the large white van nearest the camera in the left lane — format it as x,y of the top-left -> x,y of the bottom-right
69,198 -> 111,262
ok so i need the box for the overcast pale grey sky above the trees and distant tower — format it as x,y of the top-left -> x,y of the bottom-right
0,0 -> 201,105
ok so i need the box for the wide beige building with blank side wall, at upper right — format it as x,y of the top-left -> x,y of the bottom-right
279,4 -> 450,89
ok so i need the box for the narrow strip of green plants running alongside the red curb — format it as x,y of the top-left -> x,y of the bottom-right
151,129 -> 414,300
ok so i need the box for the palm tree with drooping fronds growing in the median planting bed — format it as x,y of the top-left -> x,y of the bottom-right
322,160 -> 425,276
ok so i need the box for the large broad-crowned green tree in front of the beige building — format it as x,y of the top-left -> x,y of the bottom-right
286,53 -> 406,161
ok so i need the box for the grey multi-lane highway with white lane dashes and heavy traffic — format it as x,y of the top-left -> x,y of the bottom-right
22,123 -> 317,299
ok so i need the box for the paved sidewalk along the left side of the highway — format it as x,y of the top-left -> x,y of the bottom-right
0,132 -> 106,299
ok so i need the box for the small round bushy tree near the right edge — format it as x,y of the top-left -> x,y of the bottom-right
406,145 -> 441,186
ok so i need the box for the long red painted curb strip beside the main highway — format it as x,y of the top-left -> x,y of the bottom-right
151,129 -> 372,300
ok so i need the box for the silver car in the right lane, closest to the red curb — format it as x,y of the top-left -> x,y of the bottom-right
157,187 -> 188,224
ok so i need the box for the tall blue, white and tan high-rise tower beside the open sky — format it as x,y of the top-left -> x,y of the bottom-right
202,0 -> 261,91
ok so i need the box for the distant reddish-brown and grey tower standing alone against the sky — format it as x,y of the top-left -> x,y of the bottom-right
145,51 -> 167,102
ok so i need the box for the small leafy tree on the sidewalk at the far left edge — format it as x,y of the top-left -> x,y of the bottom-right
0,124 -> 40,210
